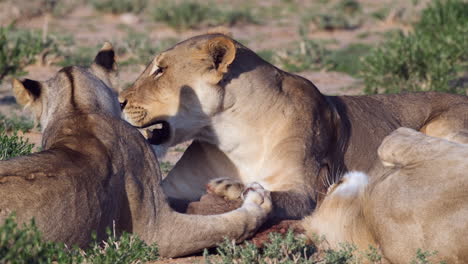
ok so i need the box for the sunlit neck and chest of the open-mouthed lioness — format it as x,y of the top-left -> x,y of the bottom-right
198,50 -> 326,190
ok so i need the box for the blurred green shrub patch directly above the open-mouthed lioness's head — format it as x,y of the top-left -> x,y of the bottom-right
151,0 -> 259,30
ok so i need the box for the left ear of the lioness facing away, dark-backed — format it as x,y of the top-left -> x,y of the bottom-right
12,79 -> 42,106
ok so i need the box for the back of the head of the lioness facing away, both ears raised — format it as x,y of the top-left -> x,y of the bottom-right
12,42 -> 120,130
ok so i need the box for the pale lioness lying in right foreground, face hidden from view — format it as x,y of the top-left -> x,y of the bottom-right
303,128 -> 468,263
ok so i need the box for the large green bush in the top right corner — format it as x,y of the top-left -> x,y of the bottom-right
361,0 -> 468,94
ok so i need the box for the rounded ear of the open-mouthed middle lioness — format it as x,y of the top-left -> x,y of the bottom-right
205,36 -> 236,73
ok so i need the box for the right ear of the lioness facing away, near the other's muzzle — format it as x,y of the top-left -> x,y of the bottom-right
91,42 -> 117,91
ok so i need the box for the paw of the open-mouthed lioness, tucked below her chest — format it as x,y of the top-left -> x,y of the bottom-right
206,178 -> 244,200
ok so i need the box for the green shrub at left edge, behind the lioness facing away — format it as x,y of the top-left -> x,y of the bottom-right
0,26 -> 54,82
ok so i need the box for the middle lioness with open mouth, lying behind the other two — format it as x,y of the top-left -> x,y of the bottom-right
119,34 -> 468,219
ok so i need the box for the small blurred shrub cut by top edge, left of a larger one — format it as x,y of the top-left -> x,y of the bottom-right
91,0 -> 148,14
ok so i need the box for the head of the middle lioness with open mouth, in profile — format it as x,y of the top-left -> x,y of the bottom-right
119,34 -> 236,154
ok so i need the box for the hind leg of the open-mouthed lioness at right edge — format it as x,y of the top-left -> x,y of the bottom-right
420,105 -> 468,144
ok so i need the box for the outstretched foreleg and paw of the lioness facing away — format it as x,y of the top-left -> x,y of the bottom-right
154,183 -> 272,257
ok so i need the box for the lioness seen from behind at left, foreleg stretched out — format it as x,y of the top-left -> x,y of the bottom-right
0,44 -> 271,257
